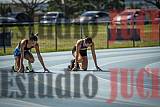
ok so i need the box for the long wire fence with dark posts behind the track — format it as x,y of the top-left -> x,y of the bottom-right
0,21 -> 160,55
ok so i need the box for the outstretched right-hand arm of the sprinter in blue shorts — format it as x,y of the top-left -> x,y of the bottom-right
35,43 -> 49,72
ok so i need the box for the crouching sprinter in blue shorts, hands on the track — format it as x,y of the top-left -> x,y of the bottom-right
13,34 -> 49,72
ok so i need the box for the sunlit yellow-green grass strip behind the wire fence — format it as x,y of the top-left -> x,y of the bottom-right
0,24 -> 159,55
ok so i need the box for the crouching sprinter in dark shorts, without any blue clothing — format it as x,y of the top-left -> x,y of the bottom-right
69,37 -> 101,71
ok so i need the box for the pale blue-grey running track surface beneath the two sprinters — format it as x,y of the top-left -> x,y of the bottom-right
0,47 -> 160,107
